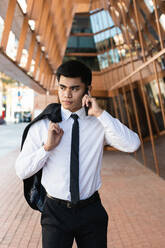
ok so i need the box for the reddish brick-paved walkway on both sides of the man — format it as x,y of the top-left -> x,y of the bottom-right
0,148 -> 165,248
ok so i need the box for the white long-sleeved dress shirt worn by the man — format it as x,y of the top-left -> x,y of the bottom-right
15,108 -> 140,200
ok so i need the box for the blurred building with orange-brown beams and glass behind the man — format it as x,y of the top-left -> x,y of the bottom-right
0,0 -> 165,177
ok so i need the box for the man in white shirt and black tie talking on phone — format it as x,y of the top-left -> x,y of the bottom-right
16,60 -> 140,248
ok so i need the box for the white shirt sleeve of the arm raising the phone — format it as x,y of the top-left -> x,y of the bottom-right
97,110 -> 140,152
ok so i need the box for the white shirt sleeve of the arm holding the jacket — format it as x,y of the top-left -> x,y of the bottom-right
15,123 -> 50,179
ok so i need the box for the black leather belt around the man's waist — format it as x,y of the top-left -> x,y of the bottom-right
47,191 -> 100,208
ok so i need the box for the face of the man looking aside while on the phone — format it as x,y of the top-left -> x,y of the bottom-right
58,75 -> 85,112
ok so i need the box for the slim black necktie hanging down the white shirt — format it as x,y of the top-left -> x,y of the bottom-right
70,114 -> 80,203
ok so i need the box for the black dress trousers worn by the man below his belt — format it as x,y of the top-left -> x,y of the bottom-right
41,193 -> 108,248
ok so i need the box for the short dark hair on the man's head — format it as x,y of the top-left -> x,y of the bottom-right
56,60 -> 92,86
